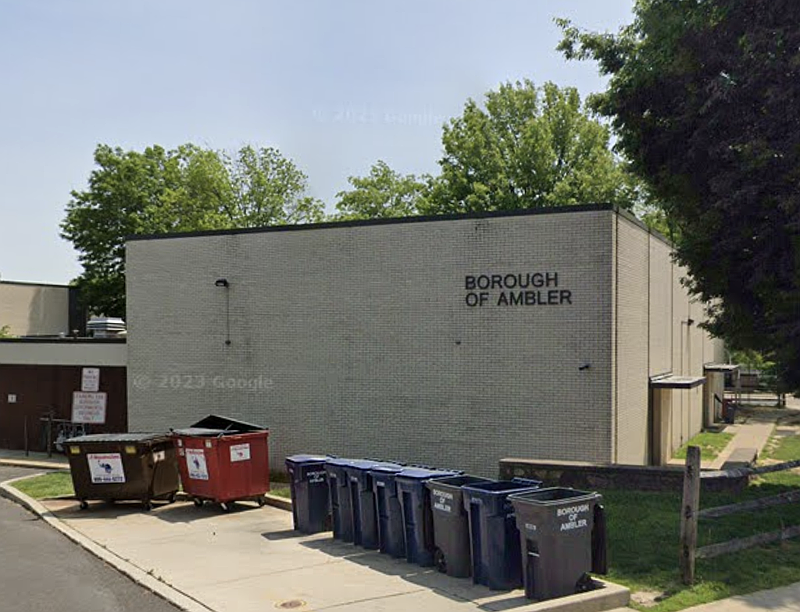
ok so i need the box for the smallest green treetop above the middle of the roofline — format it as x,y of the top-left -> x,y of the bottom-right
333,160 -> 431,221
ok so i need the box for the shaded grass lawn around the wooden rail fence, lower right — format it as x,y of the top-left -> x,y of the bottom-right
603,472 -> 800,612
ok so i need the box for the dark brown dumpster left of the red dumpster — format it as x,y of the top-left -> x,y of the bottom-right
64,433 -> 179,510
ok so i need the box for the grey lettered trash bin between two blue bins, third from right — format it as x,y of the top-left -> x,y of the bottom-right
426,475 -> 491,578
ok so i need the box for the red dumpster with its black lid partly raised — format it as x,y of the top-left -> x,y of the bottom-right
172,415 -> 269,512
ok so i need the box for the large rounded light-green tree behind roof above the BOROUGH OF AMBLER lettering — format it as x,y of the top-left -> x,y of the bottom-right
425,80 -> 638,213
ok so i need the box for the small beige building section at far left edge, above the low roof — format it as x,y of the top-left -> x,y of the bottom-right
0,281 -> 75,336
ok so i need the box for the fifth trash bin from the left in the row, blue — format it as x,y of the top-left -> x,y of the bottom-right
395,467 -> 455,567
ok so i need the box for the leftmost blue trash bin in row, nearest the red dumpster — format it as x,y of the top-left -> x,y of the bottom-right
286,455 -> 331,533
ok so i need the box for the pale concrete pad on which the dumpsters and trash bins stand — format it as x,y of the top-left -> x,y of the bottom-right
25,501 -> 628,612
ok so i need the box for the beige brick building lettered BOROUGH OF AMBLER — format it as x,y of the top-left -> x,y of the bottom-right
126,206 -> 722,475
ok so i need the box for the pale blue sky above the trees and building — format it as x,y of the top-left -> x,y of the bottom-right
0,0 -> 633,283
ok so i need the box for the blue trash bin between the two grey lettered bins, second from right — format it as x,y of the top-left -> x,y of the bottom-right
462,479 -> 541,590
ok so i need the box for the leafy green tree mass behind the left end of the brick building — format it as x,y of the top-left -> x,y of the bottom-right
61,144 -> 323,316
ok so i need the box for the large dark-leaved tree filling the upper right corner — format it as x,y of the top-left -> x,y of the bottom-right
560,0 -> 800,389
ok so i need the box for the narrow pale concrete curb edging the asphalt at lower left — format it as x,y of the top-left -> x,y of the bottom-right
0,474 -> 216,612
